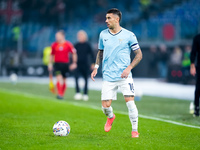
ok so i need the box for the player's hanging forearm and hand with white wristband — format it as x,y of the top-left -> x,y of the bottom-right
91,50 -> 103,81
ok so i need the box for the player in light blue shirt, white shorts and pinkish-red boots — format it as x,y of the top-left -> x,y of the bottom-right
91,8 -> 142,138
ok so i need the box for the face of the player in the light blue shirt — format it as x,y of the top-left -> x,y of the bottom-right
105,13 -> 119,29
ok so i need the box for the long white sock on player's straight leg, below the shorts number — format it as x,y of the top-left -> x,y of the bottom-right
126,101 -> 138,131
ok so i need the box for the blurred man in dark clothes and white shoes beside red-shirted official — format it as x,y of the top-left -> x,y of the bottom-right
74,30 -> 95,101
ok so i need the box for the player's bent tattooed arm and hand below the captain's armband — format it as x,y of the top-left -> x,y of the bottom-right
121,48 -> 142,78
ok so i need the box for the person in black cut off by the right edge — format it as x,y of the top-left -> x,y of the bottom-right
190,34 -> 200,117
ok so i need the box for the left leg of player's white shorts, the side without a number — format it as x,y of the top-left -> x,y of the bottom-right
101,81 -> 118,101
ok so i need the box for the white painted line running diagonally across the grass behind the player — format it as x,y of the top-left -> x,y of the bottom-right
0,88 -> 200,129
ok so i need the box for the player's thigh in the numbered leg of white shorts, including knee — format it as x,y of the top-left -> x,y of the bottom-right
119,78 -> 135,100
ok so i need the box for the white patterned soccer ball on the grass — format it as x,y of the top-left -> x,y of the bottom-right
53,121 -> 70,136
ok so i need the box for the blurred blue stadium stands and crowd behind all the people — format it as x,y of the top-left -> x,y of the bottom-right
0,0 -> 200,84
